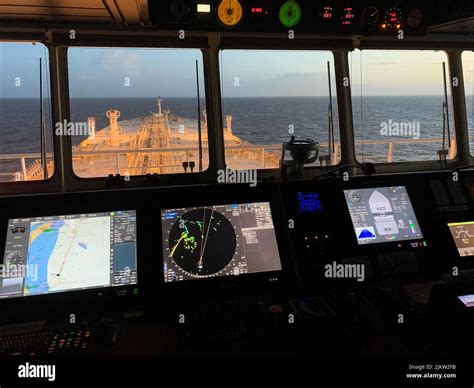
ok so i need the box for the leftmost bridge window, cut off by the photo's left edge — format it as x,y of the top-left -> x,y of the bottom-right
0,42 -> 54,182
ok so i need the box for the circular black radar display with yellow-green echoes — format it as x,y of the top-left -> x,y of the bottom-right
168,208 -> 237,277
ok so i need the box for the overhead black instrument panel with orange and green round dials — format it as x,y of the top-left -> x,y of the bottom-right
149,0 -> 438,35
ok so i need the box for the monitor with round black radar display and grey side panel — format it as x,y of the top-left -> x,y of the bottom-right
161,202 -> 282,282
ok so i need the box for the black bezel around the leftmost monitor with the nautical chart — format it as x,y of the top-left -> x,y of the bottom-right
0,191 -> 143,323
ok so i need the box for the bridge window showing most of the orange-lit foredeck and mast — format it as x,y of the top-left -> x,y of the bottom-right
67,47 -> 209,178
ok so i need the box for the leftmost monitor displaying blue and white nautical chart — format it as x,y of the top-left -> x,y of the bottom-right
0,210 -> 137,298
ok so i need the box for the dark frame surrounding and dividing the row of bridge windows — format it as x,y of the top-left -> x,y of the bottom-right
0,31 -> 474,196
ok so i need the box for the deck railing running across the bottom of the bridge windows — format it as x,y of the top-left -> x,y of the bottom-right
0,137 -> 460,181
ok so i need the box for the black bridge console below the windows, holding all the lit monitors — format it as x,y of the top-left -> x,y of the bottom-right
0,171 -> 474,384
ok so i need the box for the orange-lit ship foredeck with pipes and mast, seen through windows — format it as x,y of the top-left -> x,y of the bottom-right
15,97 -> 281,180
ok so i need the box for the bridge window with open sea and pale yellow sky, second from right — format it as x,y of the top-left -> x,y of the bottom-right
349,50 -> 456,163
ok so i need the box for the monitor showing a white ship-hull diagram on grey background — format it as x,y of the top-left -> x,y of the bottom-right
344,186 -> 423,245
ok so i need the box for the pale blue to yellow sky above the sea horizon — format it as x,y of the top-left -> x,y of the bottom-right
0,43 -> 474,98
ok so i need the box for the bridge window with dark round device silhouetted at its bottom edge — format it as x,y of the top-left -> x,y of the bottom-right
220,50 -> 340,170
